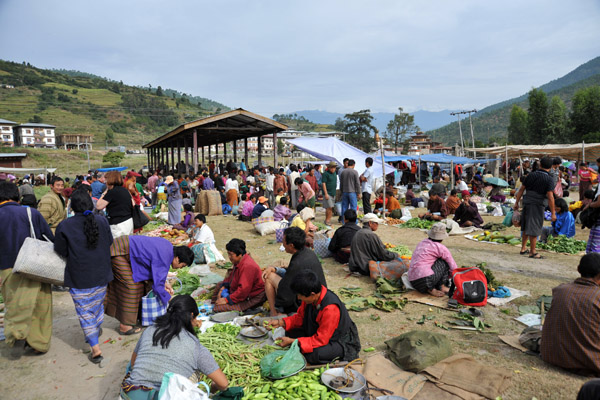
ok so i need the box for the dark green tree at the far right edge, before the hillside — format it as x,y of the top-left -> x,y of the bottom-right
570,86 -> 600,142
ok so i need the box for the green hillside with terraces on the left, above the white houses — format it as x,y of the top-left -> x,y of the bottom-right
0,60 -> 229,148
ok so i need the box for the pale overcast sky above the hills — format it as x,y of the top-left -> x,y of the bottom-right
0,0 -> 600,116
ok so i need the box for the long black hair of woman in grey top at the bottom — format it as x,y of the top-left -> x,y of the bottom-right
152,296 -> 199,349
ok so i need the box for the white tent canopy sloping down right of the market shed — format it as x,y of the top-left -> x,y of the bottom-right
287,137 -> 396,177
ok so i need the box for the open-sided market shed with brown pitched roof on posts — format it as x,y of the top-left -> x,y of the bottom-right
143,108 -> 288,173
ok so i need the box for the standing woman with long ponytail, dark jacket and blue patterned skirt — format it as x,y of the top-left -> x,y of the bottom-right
54,189 -> 113,364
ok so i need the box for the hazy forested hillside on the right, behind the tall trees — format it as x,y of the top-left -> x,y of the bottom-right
427,57 -> 600,145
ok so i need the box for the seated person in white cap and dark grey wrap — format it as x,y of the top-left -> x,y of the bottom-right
348,213 -> 404,275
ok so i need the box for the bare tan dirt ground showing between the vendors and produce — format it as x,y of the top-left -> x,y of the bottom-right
0,208 -> 588,400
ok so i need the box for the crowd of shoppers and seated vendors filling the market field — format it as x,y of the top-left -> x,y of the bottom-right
0,152 -> 600,398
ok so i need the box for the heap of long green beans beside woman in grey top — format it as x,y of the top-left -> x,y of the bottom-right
198,331 -> 275,392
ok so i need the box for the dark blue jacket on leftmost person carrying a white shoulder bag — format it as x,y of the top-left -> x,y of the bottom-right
0,201 -> 54,270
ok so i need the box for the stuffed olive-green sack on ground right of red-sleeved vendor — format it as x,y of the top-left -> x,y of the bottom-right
385,331 -> 452,372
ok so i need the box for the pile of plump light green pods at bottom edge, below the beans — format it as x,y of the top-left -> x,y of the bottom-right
242,367 -> 342,400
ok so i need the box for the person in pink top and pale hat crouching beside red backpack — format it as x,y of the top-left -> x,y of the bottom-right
408,222 -> 457,297
